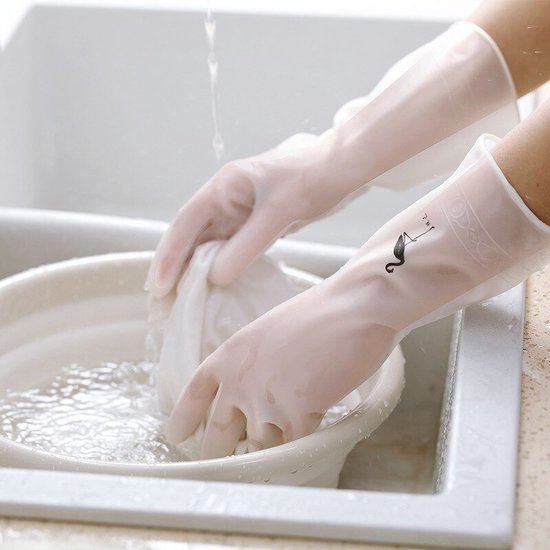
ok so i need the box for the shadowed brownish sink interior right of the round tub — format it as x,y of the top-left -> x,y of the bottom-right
339,317 -> 453,493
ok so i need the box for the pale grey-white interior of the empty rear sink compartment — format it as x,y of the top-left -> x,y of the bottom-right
0,0 -> 470,245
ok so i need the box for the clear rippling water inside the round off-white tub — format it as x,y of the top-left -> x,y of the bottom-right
0,361 -> 186,463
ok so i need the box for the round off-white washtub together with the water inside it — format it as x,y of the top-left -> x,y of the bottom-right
0,253 -> 403,487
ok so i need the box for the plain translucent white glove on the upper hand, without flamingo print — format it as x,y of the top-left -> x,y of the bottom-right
148,22 -> 517,298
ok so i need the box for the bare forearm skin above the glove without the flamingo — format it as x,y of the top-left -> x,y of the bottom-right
468,0 -> 550,96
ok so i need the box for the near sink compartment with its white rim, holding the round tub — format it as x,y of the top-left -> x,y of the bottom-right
0,209 -> 523,548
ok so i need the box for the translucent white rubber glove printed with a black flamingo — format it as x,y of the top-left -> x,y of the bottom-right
167,136 -> 550,458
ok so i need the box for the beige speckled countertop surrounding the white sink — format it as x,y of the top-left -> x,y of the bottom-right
0,266 -> 550,550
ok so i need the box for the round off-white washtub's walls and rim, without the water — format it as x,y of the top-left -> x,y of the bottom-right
0,252 -> 404,487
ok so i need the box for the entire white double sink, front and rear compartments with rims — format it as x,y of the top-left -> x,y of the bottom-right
0,0 -> 528,548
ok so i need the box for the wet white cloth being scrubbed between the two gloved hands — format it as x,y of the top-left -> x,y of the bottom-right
156,241 -> 384,460
